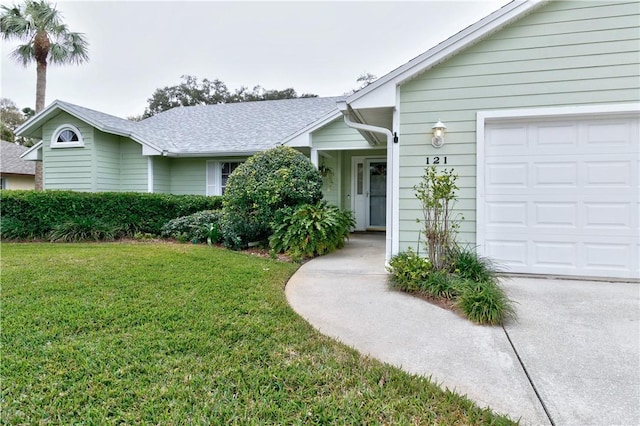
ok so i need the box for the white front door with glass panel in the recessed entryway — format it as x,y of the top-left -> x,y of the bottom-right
351,157 -> 387,231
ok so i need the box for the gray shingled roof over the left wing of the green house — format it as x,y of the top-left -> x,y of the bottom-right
16,97 -> 345,156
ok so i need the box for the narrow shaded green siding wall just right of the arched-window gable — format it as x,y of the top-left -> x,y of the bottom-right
94,129 -> 120,191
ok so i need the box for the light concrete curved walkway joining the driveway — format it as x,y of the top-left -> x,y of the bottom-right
286,234 -> 640,425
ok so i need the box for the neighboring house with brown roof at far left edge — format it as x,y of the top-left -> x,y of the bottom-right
0,141 -> 36,189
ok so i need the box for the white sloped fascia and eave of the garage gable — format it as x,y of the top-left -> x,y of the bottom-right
346,0 -> 549,109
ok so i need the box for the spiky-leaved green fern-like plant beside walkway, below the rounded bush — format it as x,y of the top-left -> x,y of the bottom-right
269,201 -> 355,261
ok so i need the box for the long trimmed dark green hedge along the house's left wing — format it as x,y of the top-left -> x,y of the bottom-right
0,190 -> 222,238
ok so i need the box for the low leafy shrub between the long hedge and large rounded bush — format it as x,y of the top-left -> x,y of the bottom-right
160,210 -> 221,243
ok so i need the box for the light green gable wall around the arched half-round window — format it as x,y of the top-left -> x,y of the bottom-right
42,112 -> 95,191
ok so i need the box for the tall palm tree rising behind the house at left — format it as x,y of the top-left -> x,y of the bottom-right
0,0 -> 89,113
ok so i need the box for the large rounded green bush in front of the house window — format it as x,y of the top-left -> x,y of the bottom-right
222,146 -> 322,249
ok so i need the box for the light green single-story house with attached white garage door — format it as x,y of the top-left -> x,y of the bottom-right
18,0 -> 640,281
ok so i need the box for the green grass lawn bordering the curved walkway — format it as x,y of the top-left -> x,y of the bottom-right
0,243 -> 510,425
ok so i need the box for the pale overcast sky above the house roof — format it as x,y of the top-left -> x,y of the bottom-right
0,0 -> 509,118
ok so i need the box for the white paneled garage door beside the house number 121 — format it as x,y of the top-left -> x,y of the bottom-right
478,115 -> 640,279
